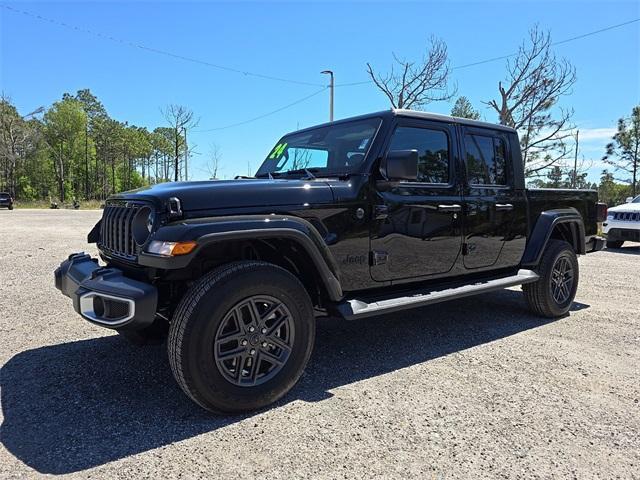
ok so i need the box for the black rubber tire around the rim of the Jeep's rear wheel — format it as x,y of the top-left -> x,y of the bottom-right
522,239 -> 579,318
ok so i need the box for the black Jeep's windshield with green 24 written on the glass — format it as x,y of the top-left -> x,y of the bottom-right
256,118 -> 380,177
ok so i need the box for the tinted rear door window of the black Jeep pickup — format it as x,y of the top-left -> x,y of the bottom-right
464,134 -> 507,185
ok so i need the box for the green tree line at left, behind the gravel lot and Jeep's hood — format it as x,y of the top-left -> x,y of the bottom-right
0,90 -> 196,203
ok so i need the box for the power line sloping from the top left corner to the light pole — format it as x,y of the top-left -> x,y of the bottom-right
0,4 -> 323,87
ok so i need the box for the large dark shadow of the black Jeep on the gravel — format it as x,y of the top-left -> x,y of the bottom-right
0,290 -> 588,474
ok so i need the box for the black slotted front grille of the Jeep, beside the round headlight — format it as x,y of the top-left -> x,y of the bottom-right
98,202 -> 144,260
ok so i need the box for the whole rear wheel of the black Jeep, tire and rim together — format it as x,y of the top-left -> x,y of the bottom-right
522,239 -> 579,318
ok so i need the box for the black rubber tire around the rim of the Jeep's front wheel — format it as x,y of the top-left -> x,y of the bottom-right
167,261 -> 315,413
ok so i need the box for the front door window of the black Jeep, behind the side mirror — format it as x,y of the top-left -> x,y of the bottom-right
389,127 -> 449,183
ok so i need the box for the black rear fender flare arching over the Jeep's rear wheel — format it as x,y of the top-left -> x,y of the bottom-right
521,208 -> 586,267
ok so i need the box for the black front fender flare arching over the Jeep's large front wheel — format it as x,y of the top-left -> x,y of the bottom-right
138,215 -> 343,301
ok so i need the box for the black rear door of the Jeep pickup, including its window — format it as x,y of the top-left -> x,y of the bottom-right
460,127 -> 527,269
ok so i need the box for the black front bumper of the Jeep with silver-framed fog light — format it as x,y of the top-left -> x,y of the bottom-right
54,253 -> 158,330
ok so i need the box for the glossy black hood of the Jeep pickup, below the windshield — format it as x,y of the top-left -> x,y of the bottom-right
111,179 -> 333,212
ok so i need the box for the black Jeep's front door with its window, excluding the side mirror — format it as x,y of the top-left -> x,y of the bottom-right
371,119 -> 462,281
